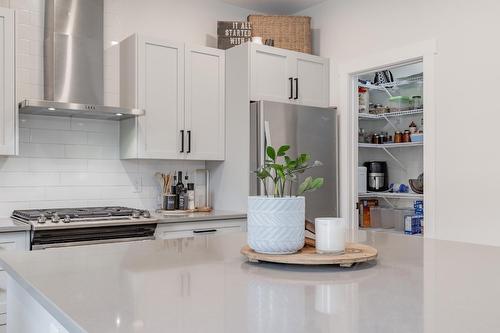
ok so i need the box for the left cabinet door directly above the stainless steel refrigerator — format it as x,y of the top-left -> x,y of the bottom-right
250,44 -> 295,103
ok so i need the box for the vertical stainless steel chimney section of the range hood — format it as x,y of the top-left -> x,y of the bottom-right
44,0 -> 104,105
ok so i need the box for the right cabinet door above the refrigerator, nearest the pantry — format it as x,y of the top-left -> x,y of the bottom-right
294,53 -> 330,107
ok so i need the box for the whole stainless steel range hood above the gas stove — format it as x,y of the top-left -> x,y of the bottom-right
19,0 -> 144,120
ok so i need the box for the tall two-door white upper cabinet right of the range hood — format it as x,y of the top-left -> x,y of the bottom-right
120,35 -> 224,160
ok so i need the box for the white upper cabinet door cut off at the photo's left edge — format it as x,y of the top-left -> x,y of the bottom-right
0,8 -> 17,155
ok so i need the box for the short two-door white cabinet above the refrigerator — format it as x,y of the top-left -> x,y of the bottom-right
249,43 -> 329,107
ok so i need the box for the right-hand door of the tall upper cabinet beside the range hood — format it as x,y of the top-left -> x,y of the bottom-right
185,46 -> 225,160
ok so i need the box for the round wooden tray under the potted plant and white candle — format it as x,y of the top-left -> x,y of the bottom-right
241,243 -> 377,267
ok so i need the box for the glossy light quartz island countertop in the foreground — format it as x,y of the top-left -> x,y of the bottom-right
0,232 -> 500,333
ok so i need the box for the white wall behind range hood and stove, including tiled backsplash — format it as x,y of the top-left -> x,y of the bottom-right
0,0 -> 249,217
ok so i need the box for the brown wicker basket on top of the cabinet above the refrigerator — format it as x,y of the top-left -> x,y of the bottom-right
248,15 -> 312,53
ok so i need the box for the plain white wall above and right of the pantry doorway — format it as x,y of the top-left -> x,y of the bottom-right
299,0 -> 500,245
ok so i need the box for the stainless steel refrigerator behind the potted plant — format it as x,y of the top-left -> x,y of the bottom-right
250,101 -> 338,220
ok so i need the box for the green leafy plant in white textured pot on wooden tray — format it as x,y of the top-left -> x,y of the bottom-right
248,145 -> 324,254
